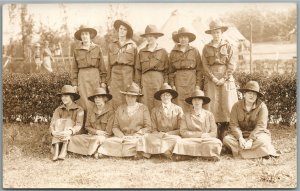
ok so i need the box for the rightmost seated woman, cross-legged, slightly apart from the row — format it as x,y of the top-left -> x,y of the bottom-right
223,81 -> 278,158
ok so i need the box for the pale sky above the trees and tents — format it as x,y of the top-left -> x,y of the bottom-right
2,3 -> 296,44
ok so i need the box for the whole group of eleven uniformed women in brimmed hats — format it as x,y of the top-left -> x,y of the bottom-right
50,20 -> 278,161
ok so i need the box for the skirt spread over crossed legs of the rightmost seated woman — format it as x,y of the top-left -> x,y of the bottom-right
223,133 -> 279,159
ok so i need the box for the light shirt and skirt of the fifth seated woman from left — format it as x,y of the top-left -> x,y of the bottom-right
173,110 -> 222,158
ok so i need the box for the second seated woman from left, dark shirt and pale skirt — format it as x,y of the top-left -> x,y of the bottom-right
68,88 -> 114,158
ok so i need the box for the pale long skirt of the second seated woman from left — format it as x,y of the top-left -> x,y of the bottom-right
68,134 -> 108,155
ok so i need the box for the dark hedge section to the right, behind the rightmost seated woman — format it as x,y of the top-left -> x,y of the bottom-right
235,72 -> 297,125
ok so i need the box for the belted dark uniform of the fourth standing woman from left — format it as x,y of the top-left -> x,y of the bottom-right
169,45 -> 202,112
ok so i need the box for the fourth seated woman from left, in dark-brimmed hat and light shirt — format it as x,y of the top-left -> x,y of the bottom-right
137,84 -> 183,159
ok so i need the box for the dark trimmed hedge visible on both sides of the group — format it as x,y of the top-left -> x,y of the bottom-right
3,72 -> 297,125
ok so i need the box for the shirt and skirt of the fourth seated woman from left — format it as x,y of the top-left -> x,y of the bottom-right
137,103 -> 183,154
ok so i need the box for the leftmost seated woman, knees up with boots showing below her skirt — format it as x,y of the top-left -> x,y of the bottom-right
50,85 -> 84,161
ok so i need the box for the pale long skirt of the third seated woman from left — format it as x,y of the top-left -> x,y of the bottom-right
98,136 -> 141,157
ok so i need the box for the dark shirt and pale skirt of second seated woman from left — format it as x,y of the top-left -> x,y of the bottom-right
68,105 -> 114,155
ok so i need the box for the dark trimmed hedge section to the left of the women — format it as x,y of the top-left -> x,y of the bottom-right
3,72 -> 70,123
